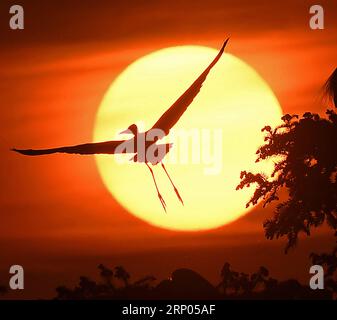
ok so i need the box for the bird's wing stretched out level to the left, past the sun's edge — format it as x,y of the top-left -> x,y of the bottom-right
12,140 -> 126,156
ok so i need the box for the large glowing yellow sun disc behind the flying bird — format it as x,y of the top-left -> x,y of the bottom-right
93,46 -> 281,231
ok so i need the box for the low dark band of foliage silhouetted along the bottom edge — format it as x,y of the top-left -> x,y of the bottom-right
55,263 -> 330,300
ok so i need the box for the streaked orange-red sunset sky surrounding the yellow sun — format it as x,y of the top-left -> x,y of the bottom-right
0,0 -> 337,298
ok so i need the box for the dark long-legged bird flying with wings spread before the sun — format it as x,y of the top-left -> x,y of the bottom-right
12,38 -> 229,212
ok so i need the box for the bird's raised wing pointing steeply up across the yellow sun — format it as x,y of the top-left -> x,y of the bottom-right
152,39 -> 229,135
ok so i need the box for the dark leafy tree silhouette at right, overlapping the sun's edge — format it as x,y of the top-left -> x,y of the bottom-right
237,69 -> 337,251
